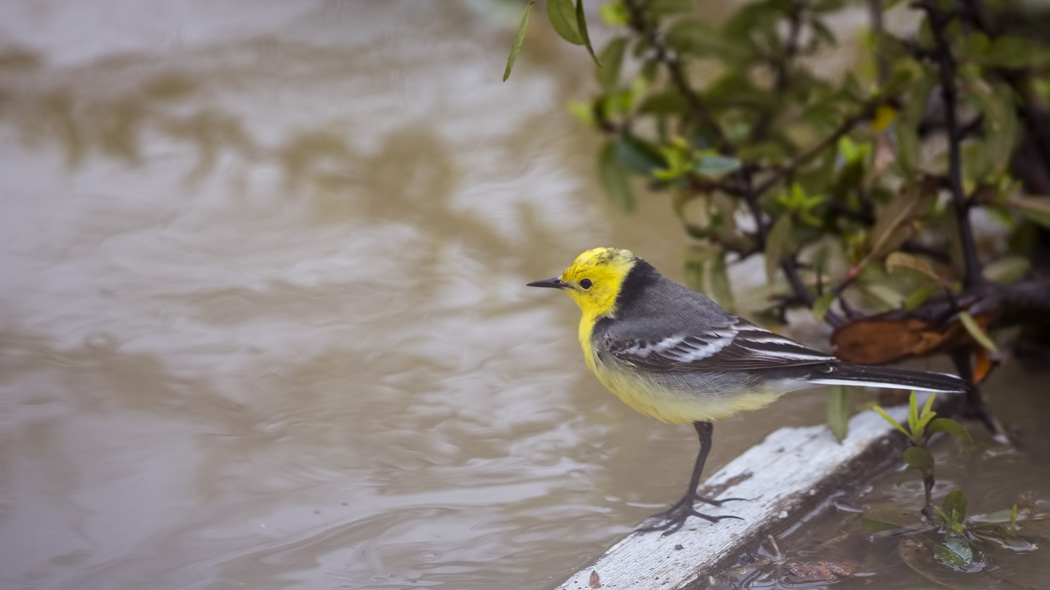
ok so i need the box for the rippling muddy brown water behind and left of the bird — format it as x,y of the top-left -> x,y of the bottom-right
0,0 -> 1041,589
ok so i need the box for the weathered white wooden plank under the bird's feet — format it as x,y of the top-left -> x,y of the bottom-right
559,407 -> 907,590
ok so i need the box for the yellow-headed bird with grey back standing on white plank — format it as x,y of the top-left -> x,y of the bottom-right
527,248 -> 968,535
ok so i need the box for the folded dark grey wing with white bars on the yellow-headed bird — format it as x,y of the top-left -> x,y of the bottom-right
601,314 -> 838,372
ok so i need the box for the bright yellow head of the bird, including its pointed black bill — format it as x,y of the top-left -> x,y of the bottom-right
528,248 -> 638,318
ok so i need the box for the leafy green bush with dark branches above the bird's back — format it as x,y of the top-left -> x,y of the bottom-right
499,0 -> 1050,350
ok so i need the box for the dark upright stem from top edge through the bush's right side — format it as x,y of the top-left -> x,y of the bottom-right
922,0 -> 984,289
